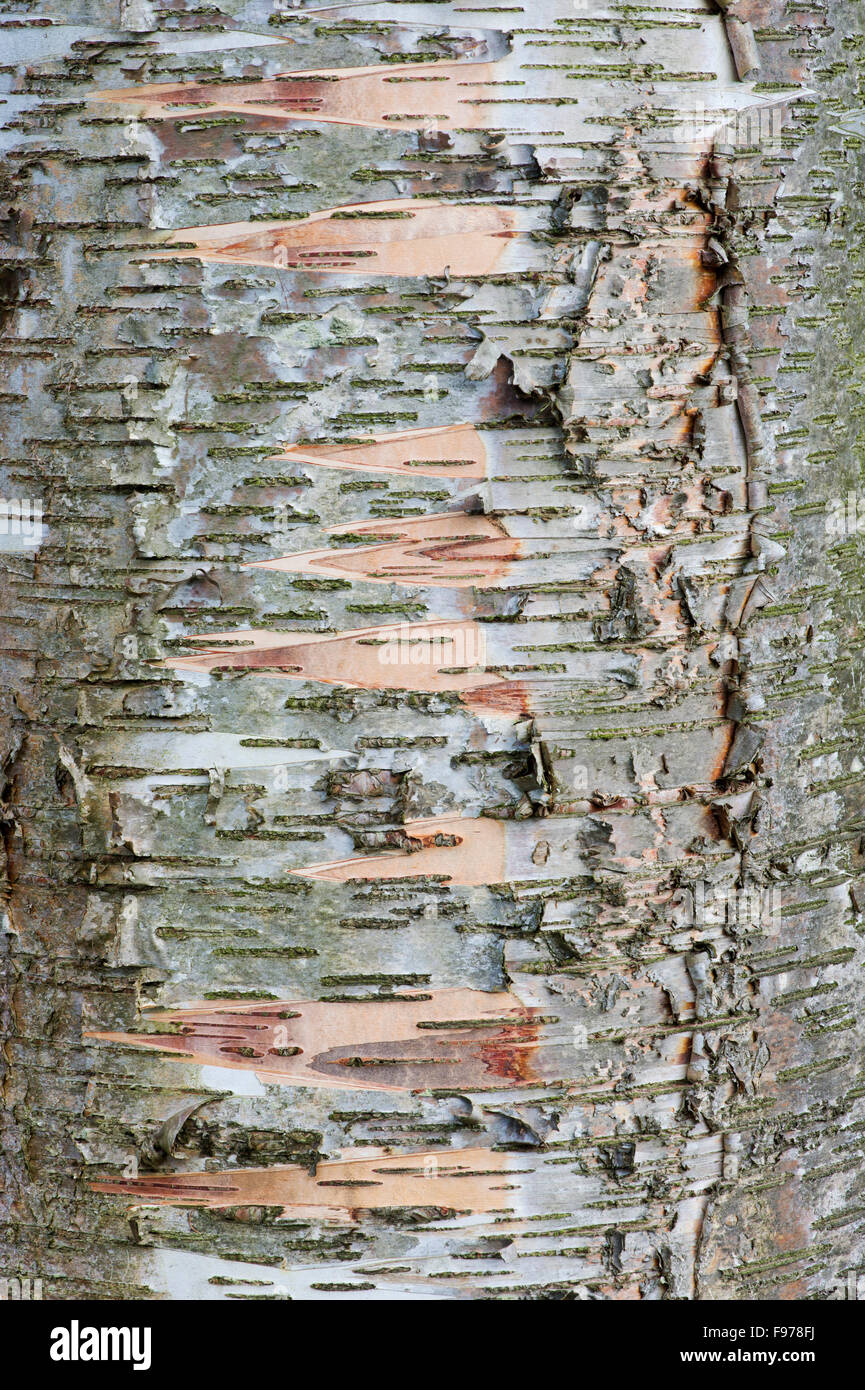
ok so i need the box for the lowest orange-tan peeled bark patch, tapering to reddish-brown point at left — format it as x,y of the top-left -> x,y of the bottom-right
92,1148 -> 520,1220
